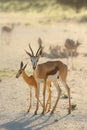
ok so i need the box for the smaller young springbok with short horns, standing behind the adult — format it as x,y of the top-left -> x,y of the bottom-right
16,62 -> 51,114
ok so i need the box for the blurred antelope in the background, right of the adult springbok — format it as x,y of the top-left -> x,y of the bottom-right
64,38 -> 81,69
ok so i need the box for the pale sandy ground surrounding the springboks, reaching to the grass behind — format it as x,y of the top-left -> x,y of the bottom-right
0,20 -> 87,130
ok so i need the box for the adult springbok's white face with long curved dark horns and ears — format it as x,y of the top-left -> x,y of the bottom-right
25,44 -> 42,70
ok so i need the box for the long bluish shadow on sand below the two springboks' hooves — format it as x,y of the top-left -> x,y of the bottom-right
0,114 -> 70,130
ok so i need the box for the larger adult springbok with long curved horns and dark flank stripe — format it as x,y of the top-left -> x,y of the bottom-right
25,44 -> 71,114
